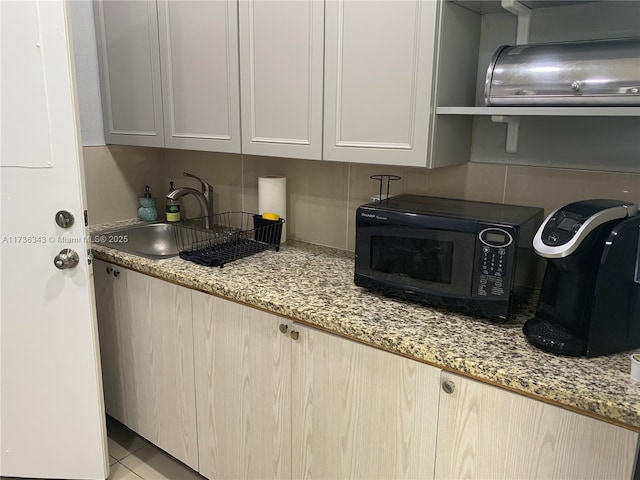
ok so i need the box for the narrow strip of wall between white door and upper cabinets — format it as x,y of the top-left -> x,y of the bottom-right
68,0 -> 105,146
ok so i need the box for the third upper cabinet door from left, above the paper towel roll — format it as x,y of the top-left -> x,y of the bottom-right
239,0 -> 324,160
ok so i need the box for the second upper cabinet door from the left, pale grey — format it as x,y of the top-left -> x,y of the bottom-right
158,0 -> 240,153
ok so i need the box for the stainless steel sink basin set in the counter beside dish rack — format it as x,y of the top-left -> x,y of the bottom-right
92,223 -> 180,260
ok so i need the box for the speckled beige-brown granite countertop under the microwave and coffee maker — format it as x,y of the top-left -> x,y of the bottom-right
92,222 -> 640,432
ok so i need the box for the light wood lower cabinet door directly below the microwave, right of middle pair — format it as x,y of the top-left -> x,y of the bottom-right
291,324 -> 440,479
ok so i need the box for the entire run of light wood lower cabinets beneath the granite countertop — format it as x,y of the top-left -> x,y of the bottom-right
94,261 -> 638,480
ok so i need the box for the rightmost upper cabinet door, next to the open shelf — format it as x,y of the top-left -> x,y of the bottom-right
324,0 -> 438,167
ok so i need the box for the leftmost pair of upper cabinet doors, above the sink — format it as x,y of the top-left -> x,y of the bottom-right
95,0 -> 240,153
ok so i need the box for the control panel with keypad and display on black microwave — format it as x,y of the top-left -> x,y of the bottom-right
473,227 -> 514,299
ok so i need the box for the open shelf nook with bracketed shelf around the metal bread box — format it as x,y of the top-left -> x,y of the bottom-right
434,0 -> 640,160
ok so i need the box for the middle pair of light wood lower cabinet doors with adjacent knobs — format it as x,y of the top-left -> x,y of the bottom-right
193,292 -> 440,479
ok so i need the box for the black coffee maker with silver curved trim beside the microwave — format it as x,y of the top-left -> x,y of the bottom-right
523,200 -> 640,357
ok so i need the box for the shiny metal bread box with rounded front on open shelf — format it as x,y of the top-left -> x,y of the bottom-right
484,38 -> 640,106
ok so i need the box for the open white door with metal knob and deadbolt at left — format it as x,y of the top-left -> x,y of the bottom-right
0,0 -> 108,479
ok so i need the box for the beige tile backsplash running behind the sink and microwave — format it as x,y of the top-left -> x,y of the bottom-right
83,146 -> 640,250
